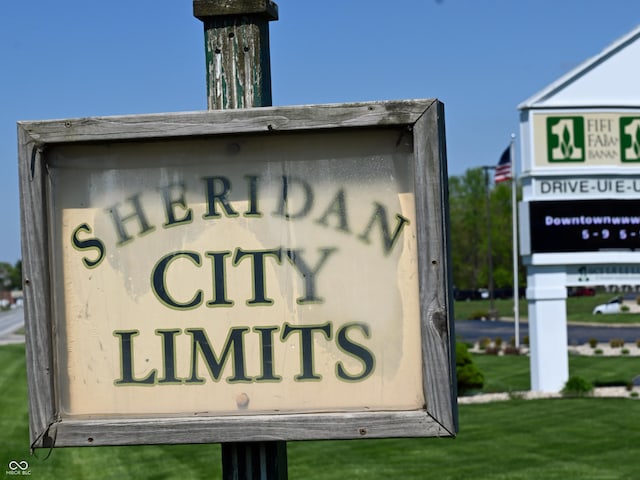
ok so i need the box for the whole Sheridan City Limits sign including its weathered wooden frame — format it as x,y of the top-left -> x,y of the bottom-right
20,101 -> 455,446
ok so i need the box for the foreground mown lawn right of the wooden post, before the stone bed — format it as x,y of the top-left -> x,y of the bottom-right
289,398 -> 640,480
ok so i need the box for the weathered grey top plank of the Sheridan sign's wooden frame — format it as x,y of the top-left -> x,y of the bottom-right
19,99 -> 434,143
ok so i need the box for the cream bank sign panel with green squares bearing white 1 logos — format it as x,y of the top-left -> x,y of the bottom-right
533,112 -> 640,168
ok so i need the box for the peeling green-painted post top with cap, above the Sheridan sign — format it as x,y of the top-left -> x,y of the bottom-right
193,0 -> 278,110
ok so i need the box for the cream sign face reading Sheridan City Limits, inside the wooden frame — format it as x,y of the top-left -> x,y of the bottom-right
50,132 -> 424,415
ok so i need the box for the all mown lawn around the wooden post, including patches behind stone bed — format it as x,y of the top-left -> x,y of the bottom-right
0,345 -> 640,480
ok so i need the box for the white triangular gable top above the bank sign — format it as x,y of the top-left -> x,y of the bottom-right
518,25 -> 640,110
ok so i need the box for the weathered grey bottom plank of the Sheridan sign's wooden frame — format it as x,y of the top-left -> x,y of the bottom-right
56,411 -> 451,446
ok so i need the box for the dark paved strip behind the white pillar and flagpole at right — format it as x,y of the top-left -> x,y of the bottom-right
455,320 -> 640,345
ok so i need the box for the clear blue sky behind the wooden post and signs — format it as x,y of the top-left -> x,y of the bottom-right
0,0 -> 640,263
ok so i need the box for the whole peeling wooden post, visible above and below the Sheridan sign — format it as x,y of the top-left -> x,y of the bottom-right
193,0 -> 288,480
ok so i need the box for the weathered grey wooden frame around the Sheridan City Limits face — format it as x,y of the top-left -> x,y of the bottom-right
18,99 -> 457,448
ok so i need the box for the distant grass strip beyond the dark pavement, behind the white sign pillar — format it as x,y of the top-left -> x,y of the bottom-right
453,292 -> 640,324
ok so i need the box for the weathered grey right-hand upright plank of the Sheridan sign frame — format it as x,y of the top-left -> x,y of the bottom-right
414,102 -> 457,434
